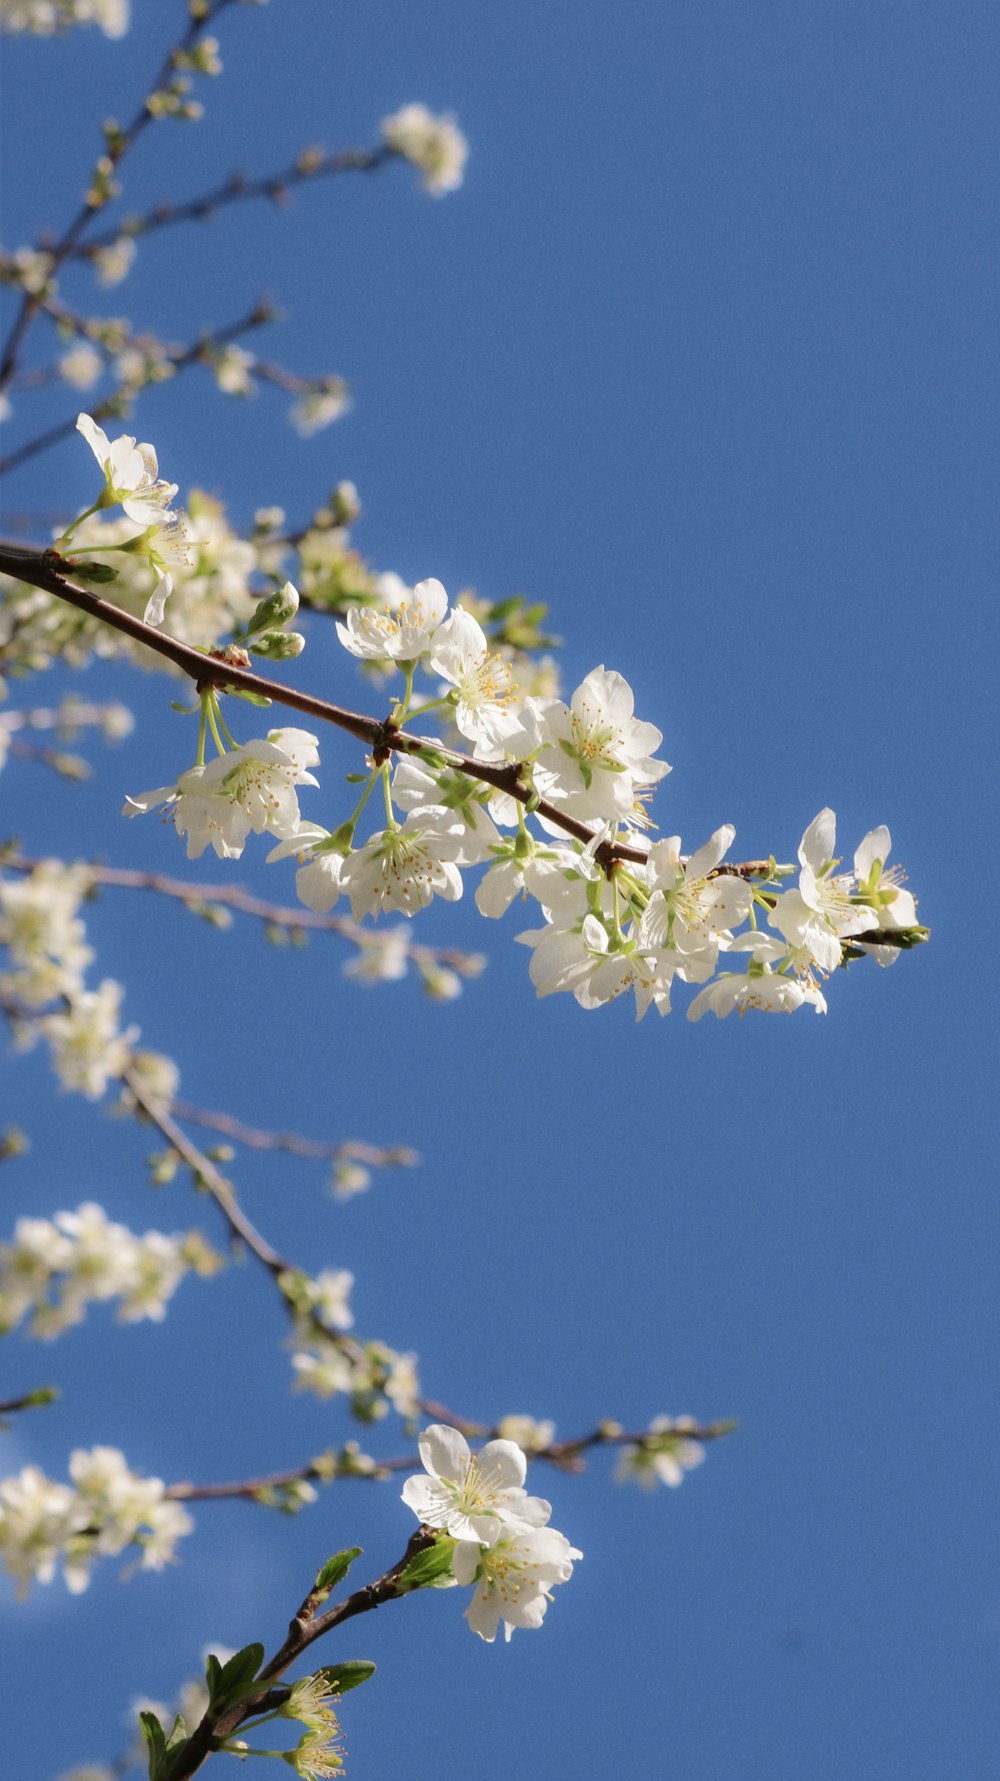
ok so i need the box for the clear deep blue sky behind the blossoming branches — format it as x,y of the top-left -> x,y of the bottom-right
0,0 -> 1000,1781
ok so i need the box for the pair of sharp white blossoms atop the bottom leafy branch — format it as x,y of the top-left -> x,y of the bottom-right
403,1423 -> 583,1644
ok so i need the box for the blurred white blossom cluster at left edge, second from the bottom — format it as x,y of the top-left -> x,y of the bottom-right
0,1200 -> 221,1339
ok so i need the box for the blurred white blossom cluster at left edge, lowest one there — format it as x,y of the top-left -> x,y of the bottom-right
0,1446 -> 194,1596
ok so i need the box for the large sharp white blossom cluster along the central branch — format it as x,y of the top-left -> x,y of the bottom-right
109,495 -> 925,1021
